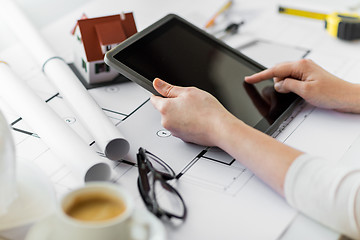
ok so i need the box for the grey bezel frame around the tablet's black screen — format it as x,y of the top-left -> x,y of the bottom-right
104,14 -> 302,135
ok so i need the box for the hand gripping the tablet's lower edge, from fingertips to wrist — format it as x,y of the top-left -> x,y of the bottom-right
151,78 -> 239,146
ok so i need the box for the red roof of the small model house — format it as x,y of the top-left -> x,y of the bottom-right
72,13 -> 137,62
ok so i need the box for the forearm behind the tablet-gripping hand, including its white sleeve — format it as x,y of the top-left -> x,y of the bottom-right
212,115 -> 360,239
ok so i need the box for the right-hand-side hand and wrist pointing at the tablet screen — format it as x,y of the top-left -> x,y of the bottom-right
245,59 -> 360,113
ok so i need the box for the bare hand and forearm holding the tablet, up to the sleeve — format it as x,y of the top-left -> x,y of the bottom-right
151,79 -> 301,194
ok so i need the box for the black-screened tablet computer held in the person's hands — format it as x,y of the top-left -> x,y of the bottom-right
105,14 -> 300,135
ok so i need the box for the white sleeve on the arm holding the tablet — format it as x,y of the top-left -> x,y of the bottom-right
284,154 -> 360,239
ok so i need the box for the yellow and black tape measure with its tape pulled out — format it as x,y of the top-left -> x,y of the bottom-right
279,6 -> 360,41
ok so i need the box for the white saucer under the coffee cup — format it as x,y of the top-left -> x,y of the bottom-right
25,210 -> 166,240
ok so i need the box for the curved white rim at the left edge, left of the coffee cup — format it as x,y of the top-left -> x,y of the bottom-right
0,160 -> 55,231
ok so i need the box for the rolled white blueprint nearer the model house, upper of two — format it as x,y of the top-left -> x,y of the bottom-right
0,0 -> 130,160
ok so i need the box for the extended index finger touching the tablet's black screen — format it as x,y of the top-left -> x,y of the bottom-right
245,62 -> 299,83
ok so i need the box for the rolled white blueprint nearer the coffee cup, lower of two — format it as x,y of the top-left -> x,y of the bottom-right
0,61 -> 112,182
